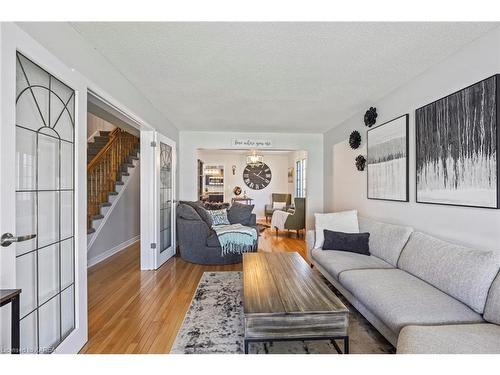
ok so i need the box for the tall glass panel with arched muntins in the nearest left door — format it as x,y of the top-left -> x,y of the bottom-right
15,53 -> 75,353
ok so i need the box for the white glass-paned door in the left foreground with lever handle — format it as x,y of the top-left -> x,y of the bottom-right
0,23 -> 87,353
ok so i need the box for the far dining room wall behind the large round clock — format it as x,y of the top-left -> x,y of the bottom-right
198,150 -> 294,218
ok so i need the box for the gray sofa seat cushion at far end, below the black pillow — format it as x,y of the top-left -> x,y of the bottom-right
311,249 -> 392,280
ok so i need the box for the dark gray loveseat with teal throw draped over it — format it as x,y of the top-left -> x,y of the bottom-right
177,202 -> 259,265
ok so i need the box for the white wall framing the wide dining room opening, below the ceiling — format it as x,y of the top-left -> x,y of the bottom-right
179,131 -> 324,228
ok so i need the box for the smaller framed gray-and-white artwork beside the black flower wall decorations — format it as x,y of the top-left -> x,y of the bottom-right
367,114 -> 408,202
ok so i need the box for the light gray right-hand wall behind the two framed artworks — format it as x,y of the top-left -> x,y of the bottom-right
324,28 -> 500,249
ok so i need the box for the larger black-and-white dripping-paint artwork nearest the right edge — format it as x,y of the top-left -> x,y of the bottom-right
415,75 -> 500,208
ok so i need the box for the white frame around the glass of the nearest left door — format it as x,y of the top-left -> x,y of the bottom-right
0,23 -> 88,353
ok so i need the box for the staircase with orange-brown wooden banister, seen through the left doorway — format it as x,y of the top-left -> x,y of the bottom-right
87,128 -> 139,235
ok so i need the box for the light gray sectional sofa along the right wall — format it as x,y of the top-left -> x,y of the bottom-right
306,217 -> 500,353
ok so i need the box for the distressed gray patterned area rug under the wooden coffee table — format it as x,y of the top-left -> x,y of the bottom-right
171,272 -> 395,354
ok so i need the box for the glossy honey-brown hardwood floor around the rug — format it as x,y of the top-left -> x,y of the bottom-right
80,225 -> 306,353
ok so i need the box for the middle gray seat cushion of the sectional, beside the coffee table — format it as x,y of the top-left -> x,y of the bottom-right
339,269 -> 483,333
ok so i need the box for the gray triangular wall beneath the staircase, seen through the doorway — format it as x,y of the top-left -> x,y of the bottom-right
88,162 -> 141,267
